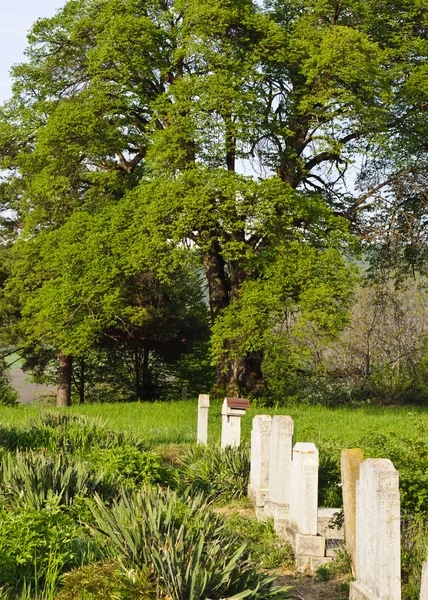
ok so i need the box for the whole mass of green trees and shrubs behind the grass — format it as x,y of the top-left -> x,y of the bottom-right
0,0 -> 428,405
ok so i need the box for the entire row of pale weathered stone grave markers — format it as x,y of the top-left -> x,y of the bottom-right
198,395 -> 428,600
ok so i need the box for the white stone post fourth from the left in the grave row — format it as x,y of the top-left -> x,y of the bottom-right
265,415 -> 294,533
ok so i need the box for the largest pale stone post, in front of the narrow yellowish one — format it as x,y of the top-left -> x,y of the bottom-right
349,458 -> 401,600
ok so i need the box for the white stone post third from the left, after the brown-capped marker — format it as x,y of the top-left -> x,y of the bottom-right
248,415 -> 272,512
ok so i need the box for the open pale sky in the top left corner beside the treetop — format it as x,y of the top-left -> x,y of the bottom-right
0,0 -> 65,102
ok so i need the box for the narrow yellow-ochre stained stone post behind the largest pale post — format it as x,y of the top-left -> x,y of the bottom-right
340,448 -> 364,577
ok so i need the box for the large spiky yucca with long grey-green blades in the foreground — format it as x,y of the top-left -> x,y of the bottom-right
92,487 -> 287,600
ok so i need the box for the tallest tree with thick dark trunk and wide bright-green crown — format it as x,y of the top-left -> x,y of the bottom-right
0,0 -> 427,392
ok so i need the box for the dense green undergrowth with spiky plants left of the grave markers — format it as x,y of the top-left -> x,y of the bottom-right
0,412 -> 287,600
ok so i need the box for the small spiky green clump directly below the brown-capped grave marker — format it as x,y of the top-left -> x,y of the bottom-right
179,444 -> 250,502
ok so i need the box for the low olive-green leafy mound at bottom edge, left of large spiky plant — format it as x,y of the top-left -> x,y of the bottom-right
55,562 -> 159,600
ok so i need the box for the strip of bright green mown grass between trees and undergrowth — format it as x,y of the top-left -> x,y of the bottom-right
0,399 -> 428,448
